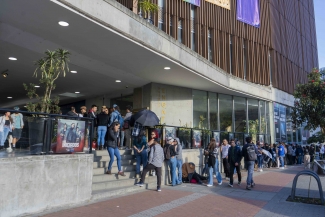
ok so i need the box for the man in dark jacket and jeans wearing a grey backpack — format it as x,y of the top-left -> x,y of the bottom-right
242,137 -> 258,190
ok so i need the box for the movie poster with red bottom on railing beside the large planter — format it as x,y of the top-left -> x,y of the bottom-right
54,119 -> 85,153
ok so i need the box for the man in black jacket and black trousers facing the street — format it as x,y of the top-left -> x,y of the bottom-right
228,139 -> 242,187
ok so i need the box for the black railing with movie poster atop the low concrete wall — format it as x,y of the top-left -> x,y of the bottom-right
0,109 -> 94,157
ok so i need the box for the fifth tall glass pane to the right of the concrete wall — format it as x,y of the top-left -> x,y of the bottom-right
248,99 -> 259,143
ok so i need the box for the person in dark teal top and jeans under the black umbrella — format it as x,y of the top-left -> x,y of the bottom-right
133,130 -> 147,178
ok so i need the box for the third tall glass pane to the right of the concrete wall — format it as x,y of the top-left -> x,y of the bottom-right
219,94 -> 233,132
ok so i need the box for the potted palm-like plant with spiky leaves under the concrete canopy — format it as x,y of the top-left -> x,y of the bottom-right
23,49 -> 70,113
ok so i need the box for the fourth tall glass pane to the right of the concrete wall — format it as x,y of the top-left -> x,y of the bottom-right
234,96 -> 247,133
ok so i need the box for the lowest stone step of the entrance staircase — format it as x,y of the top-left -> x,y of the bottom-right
91,182 -> 157,201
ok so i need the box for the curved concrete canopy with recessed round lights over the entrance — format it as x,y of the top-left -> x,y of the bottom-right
0,0 -> 293,107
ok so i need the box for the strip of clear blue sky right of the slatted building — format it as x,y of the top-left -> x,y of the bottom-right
314,0 -> 325,68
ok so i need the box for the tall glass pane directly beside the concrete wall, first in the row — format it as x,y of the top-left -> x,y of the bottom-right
192,90 -> 208,129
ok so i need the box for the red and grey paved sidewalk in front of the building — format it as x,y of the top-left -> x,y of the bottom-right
31,166 -> 325,217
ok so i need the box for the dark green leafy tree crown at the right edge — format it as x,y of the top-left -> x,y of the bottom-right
291,68 -> 325,133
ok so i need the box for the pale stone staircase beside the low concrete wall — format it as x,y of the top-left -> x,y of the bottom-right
92,150 -> 157,200
